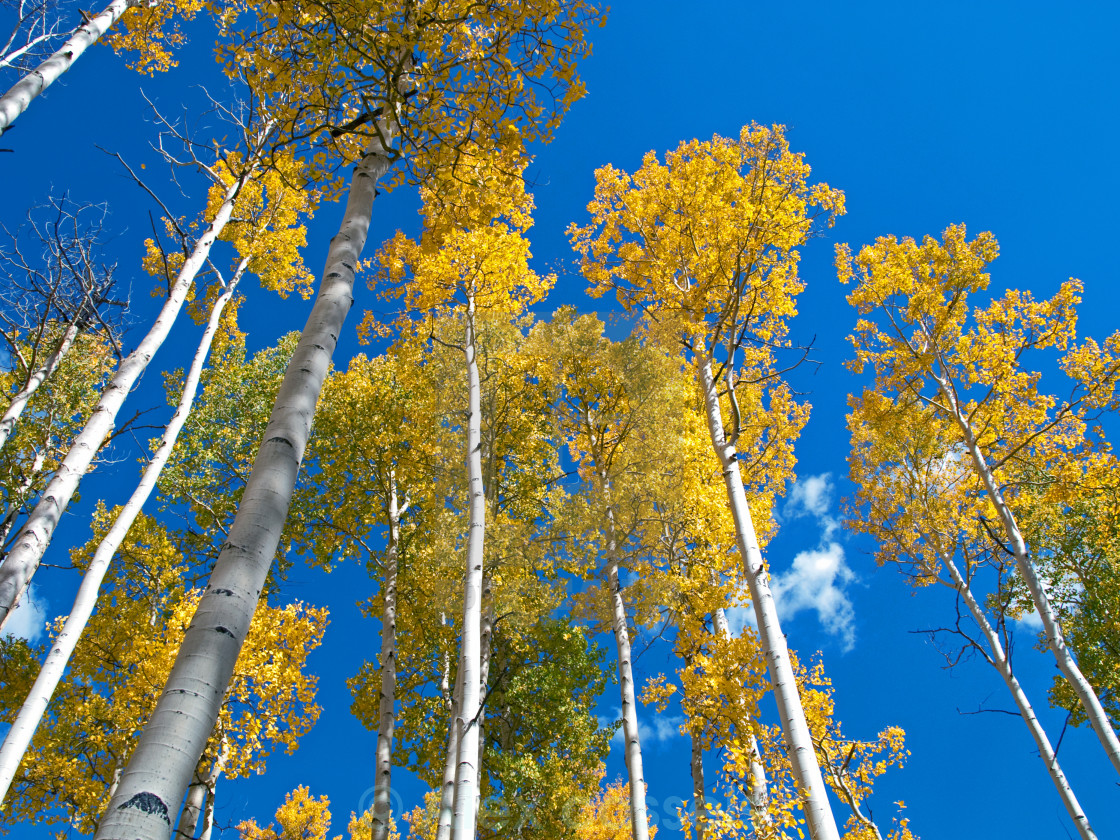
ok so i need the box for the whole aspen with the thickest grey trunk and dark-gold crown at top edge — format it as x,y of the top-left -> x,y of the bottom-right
97,0 -> 600,840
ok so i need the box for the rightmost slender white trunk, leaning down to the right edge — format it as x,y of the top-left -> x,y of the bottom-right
936,376 -> 1120,773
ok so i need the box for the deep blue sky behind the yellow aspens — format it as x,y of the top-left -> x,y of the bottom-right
0,0 -> 1120,840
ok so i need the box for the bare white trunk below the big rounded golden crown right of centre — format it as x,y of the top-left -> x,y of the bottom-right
697,355 -> 840,840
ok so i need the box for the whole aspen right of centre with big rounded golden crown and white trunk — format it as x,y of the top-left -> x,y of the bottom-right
570,125 -> 843,840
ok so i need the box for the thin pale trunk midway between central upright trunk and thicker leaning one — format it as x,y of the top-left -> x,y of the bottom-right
596,474 -> 650,840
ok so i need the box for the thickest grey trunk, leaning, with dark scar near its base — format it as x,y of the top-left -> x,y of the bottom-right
96,128 -> 391,840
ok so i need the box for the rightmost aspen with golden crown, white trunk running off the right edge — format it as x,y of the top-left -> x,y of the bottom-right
837,225 -> 1120,773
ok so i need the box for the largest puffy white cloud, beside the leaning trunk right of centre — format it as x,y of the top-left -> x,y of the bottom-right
771,542 -> 856,652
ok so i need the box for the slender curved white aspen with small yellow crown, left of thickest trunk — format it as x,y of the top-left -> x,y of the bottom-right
0,161 -> 308,801
